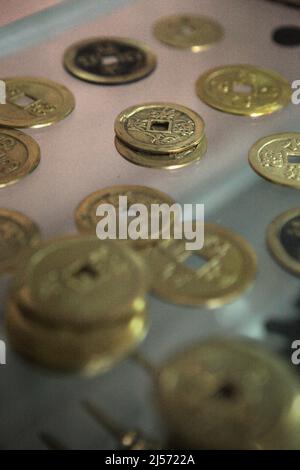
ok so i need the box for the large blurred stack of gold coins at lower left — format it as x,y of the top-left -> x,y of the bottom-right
6,236 -> 148,374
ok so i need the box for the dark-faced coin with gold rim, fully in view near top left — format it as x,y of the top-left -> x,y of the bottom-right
64,37 -> 156,85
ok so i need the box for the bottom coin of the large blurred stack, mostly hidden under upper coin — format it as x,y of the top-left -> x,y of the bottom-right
6,301 -> 148,375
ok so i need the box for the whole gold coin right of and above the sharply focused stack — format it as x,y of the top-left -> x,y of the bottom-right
196,64 -> 291,117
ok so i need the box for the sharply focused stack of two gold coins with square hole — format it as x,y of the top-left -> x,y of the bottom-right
115,103 -> 207,169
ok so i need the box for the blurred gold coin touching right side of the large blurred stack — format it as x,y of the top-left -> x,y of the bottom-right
149,224 -> 256,308
